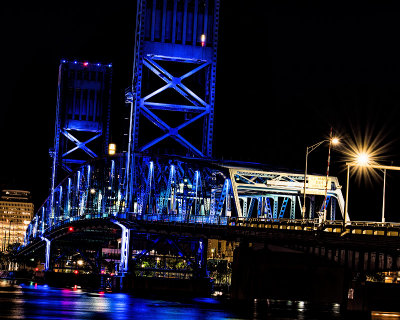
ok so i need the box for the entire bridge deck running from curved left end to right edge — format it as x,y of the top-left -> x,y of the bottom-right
19,214 -> 400,271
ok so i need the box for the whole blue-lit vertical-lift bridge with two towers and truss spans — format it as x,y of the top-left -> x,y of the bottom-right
18,0 -> 400,310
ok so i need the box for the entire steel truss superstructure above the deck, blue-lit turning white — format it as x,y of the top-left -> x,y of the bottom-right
24,155 -> 344,245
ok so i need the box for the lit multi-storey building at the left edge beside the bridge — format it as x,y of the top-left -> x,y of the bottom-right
0,190 -> 33,251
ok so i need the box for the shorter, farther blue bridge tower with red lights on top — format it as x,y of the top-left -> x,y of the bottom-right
50,60 -> 112,207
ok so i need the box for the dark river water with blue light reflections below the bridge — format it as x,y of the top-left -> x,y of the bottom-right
0,280 -> 342,320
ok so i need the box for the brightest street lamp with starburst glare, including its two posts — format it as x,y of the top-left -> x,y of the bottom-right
344,153 -> 400,224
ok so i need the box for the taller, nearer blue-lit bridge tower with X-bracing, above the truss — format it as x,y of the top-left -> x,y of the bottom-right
126,0 -> 220,209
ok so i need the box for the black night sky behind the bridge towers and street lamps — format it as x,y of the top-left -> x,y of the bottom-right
0,0 -> 400,220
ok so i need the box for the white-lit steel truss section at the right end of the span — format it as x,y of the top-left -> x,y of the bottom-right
230,168 -> 344,220
